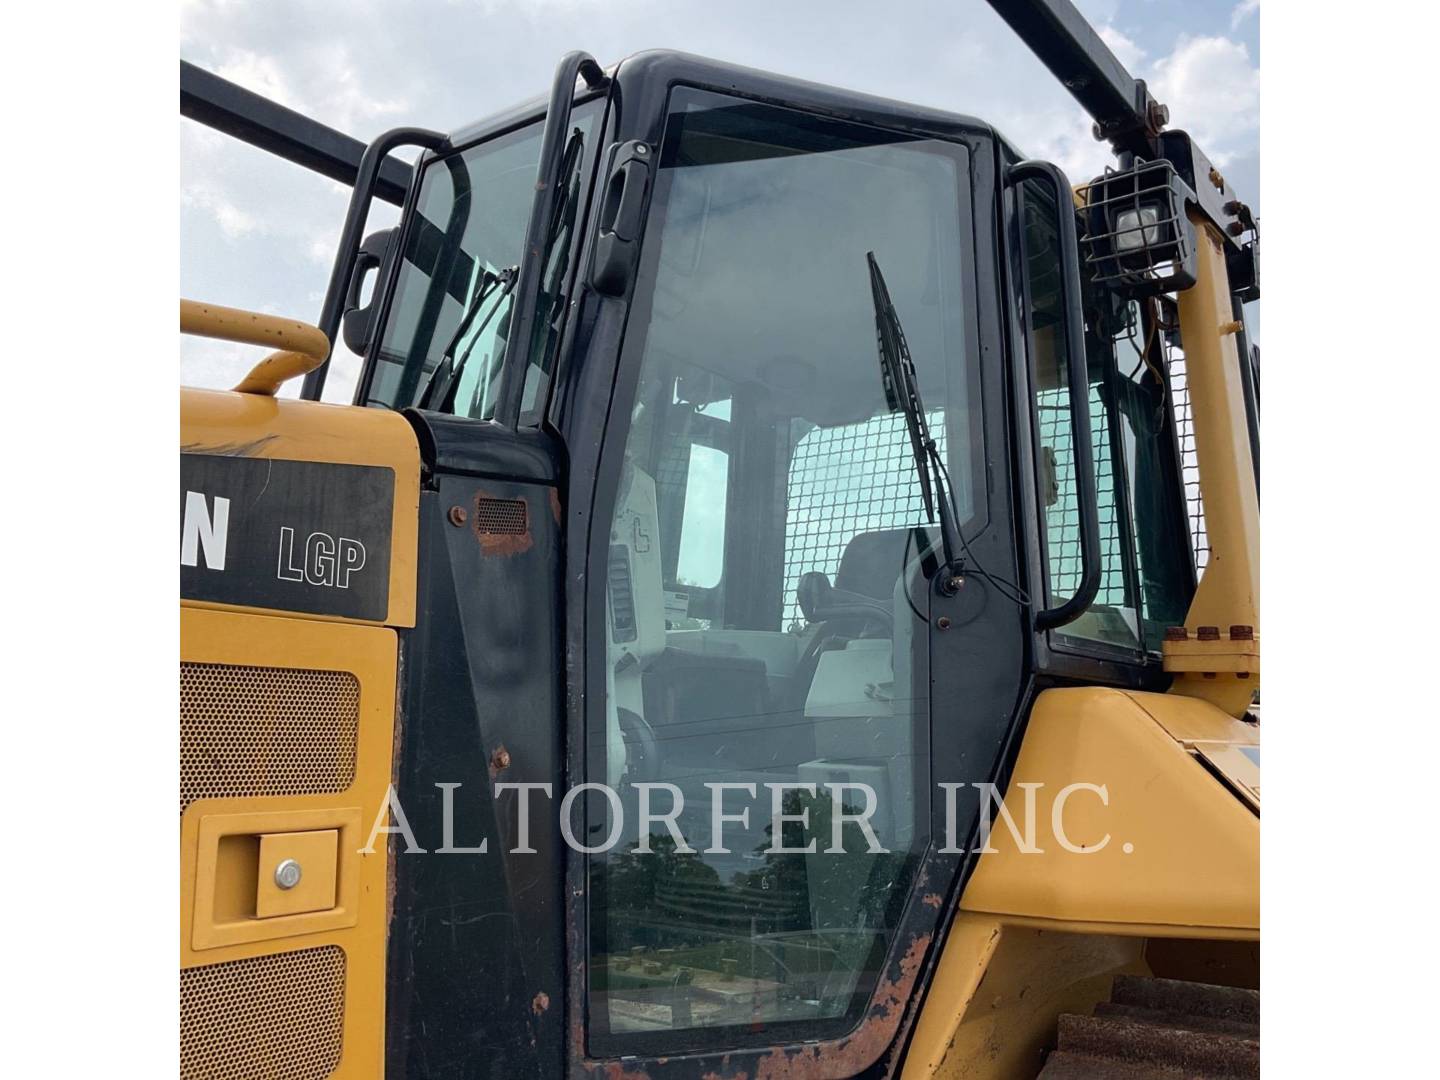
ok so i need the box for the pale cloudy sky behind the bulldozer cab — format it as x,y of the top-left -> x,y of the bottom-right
179,0 -> 1260,400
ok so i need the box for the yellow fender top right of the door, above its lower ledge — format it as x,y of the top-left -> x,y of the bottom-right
960,687 -> 1260,935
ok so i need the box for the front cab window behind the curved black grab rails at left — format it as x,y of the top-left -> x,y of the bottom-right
363,102 -> 596,420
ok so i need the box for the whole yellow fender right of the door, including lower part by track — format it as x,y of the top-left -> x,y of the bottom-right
904,687 -> 1260,1080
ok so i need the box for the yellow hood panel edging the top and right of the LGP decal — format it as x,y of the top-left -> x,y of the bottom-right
180,389 -> 420,626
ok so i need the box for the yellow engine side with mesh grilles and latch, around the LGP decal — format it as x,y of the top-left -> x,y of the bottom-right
180,389 -> 420,1079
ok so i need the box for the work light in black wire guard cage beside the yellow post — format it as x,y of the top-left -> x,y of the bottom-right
1080,160 -> 1195,298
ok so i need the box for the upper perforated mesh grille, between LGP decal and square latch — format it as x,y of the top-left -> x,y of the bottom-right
180,662 -> 360,814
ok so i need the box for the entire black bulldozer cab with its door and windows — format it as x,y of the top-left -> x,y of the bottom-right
182,38 -> 1248,1077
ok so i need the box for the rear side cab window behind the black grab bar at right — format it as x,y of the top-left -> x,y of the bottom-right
1024,184 -> 1192,652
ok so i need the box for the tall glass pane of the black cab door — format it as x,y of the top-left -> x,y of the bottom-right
589,89 -> 975,1053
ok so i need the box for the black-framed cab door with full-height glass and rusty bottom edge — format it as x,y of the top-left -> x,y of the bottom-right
554,53 -> 1027,1077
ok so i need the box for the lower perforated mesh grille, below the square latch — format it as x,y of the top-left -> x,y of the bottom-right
180,945 -> 346,1080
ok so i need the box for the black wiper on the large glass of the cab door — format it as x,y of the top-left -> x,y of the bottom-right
865,252 -> 962,596
